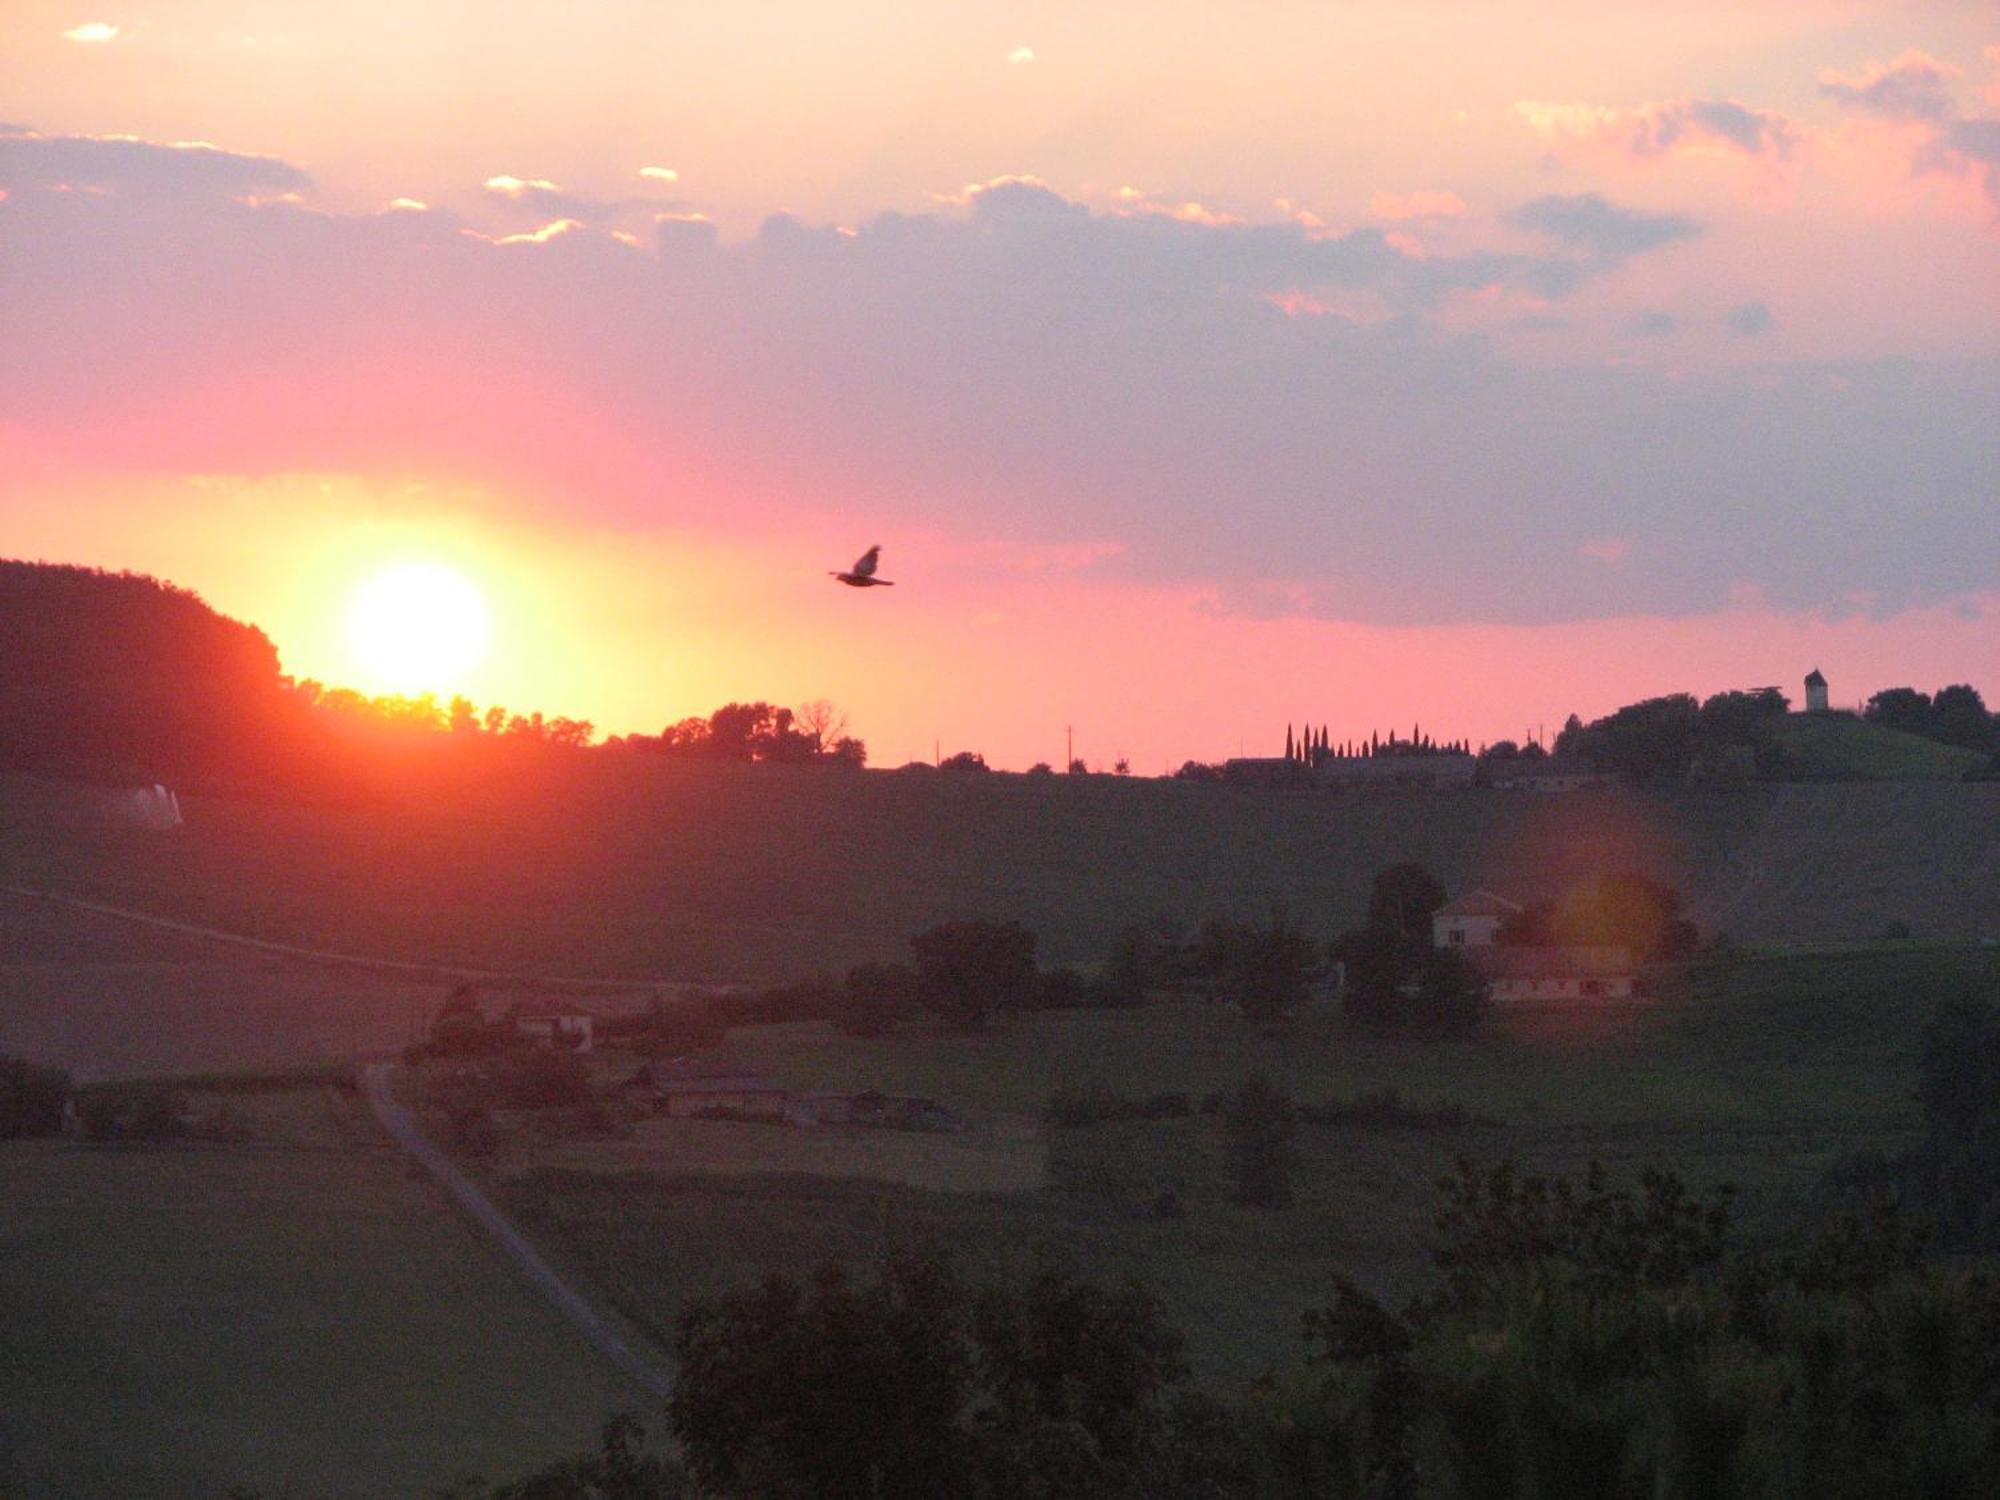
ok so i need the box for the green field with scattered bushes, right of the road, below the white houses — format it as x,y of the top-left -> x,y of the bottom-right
496,950 -> 2000,1390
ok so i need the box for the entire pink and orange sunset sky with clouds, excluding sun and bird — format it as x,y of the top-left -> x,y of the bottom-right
0,0 -> 2000,772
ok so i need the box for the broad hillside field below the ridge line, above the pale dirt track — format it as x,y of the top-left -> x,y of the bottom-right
0,756 -> 2000,982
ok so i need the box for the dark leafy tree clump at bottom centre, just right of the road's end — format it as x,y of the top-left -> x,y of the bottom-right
670,1254 -> 1248,1500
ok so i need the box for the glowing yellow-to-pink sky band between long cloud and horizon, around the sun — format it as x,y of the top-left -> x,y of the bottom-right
10,474 -> 2000,774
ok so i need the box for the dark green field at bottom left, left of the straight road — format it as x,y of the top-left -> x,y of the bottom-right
0,1090 -> 640,1500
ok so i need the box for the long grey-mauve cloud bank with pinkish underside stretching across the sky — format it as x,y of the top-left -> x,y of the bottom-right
0,125 -> 2000,624
